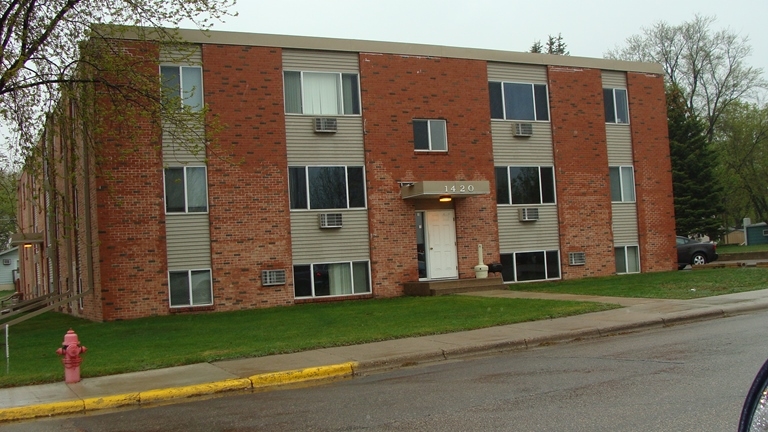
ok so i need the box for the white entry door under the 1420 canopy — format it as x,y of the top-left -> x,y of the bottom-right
424,210 -> 459,279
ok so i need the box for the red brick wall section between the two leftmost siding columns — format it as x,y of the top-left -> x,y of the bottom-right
203,45 -> 293,310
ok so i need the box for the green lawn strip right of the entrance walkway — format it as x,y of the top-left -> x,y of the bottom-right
509,267 -> 768,299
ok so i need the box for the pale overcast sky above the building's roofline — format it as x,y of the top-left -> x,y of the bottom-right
208,0 -> 768,81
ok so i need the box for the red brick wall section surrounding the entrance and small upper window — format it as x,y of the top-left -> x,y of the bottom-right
360,54 -> 499,297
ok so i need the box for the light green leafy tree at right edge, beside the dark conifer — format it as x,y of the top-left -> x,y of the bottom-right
714,102 -> 768,223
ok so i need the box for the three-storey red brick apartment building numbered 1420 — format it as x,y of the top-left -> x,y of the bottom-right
19,31 -> 676,320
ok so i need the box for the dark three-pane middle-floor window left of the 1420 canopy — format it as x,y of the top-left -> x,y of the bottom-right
288,166 -> 365,210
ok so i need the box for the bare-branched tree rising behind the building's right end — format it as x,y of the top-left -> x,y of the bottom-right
605,15 -> 767,142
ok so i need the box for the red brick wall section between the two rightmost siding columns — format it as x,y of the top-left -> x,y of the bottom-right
548,66 -> 616,279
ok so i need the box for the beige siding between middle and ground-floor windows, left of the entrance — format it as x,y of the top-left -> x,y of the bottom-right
291,210 -> 370,264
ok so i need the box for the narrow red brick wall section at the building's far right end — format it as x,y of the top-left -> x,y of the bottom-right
627,73 -> 677,271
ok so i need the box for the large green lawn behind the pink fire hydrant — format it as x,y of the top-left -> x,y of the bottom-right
0,296 -> 618,387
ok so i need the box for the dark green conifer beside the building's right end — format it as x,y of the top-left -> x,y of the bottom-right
667,87 -> 724,240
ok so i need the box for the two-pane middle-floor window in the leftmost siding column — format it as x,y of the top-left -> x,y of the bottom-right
165,167 -> 208,213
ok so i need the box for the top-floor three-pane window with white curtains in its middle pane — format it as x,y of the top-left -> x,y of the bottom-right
283,71 -> 360,115
